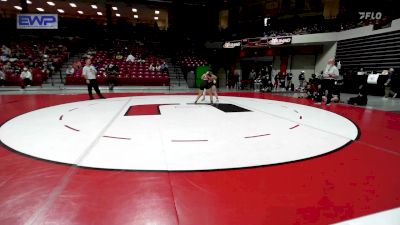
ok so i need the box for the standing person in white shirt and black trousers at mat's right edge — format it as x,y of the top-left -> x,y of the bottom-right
315,58 -> 339,105
